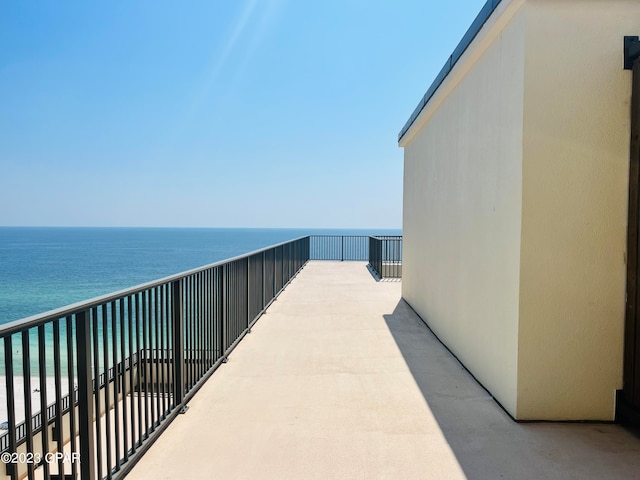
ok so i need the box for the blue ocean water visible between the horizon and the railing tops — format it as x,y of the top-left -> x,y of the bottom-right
0,227 -> 400,324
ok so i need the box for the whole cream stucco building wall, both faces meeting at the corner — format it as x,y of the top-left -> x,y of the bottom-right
400,0 -> 640,420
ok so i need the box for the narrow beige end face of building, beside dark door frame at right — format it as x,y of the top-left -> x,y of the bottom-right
517,0 -> 640,420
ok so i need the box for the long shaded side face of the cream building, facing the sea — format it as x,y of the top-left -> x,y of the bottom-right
402,0 -> 525,414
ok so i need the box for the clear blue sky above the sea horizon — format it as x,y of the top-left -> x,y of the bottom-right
0,0 -> 484,228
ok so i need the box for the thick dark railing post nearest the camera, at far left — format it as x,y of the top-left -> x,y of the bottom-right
76,310 -> 100,480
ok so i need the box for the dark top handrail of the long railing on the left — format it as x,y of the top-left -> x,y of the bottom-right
0,235 -> 310,338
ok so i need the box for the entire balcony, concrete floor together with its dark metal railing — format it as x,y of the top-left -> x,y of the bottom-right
2,237 -> 640,479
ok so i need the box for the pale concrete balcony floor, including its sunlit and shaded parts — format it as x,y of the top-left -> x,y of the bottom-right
129,262 -> 640,480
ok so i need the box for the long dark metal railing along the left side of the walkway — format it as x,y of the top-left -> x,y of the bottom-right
0,237 -> 310,480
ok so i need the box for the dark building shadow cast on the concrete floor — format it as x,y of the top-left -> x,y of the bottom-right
384,300 -> 640,480
